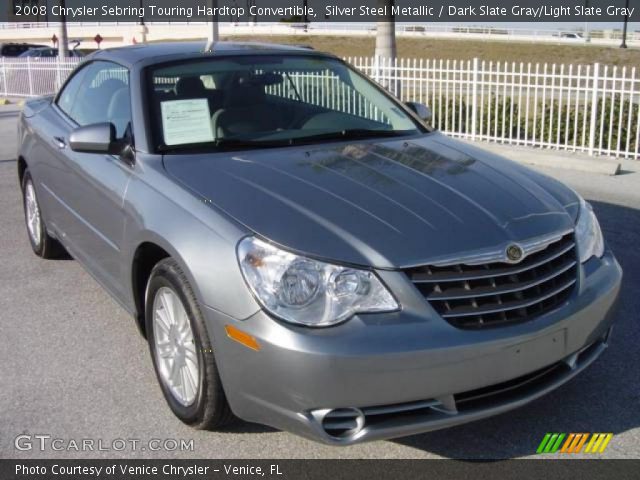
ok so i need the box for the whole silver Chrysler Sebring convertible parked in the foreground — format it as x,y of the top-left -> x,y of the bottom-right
18,42 -> 622,445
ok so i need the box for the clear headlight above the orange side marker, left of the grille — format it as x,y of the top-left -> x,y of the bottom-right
238,237 -> 398,327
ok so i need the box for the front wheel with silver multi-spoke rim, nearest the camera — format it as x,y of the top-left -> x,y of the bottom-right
145,258 -> 235,430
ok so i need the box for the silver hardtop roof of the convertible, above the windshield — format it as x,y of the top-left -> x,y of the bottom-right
90,42 -> 333,68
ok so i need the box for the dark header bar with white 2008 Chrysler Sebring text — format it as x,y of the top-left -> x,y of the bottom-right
5,0 -> 640,23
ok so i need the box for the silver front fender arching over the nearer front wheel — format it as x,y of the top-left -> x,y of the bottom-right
123,157 -> 260,319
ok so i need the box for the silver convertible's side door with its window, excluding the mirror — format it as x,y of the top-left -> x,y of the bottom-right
47,61 -> 133,297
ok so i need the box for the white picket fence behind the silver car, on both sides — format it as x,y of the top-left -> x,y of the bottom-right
0,54 -> 640,159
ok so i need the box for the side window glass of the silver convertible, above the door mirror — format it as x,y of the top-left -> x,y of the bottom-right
59,61 -> 131,138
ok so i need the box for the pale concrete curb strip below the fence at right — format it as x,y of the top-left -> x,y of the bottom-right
468,142 -> 620,175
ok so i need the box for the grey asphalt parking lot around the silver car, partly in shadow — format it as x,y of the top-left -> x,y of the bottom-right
0,107 -> 640,459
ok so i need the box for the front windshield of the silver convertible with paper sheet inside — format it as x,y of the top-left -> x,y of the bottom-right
148,55 -> 425,152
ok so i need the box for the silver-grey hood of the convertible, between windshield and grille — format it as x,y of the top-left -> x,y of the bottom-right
164,133 -> 578,268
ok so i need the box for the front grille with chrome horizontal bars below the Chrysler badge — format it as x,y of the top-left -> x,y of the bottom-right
406,233 -> 577,329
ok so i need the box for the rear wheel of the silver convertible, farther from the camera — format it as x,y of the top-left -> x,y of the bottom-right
22,169 -> 64,259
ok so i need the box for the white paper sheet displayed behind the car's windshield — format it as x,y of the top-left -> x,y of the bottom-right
160,98 -> 215,145
